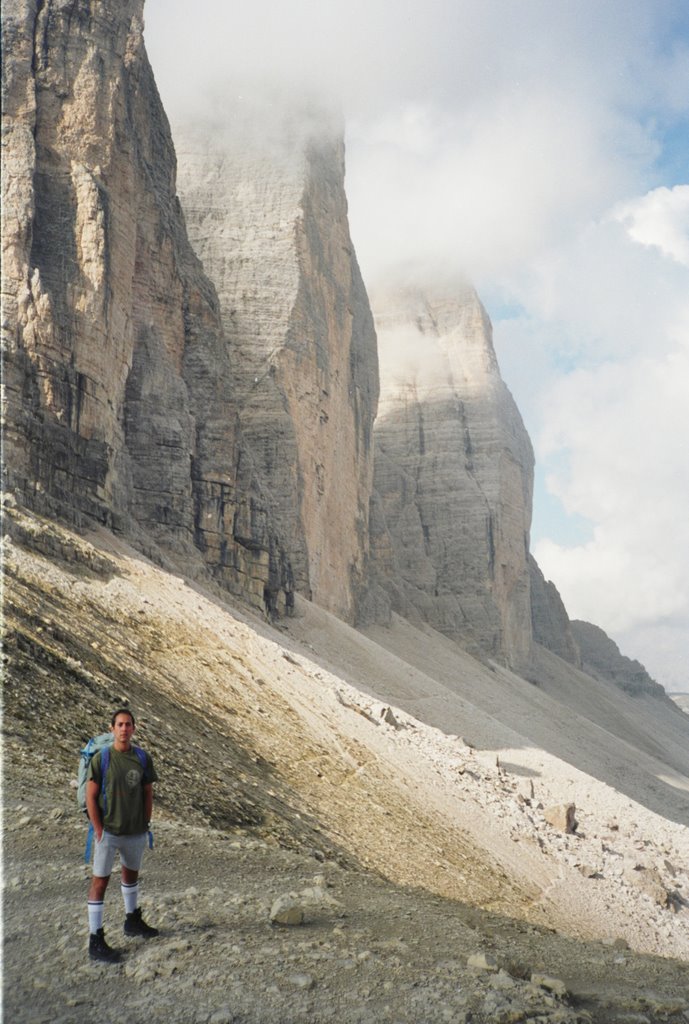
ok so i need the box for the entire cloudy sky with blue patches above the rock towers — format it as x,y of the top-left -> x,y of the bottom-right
145,0 -> 689,689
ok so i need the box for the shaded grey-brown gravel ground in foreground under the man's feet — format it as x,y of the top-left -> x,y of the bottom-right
4,770 -> 689,1024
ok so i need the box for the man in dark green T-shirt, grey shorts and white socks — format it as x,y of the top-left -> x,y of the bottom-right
86,708 -> 158,963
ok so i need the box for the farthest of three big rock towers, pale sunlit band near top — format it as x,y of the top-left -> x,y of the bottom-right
372,286 -> 533,666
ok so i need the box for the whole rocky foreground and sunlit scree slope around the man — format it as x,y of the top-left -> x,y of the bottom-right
3,512 -> 689,1024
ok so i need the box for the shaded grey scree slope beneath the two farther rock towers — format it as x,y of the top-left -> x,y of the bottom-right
288,602 -> 689,824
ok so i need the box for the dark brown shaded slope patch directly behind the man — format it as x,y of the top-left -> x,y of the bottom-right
3,516 -> 344,861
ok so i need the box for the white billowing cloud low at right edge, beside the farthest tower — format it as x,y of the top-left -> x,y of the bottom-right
534,350 -> 689,633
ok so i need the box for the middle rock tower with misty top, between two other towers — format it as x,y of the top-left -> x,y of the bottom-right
174,112 -> 378,621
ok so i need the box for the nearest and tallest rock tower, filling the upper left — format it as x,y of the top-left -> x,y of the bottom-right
2,0 -> 292,607
